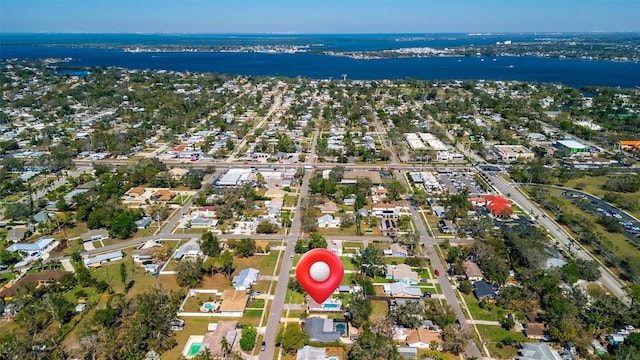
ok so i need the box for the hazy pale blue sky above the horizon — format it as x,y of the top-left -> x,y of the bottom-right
0,0 -> 640,33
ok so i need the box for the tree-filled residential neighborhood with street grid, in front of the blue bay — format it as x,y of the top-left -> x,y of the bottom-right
0,59 -> 640,360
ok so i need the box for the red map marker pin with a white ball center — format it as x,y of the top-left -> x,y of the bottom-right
296,249 -> 344,304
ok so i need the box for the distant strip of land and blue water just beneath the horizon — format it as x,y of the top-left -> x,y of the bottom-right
0,33 -> 640,62
